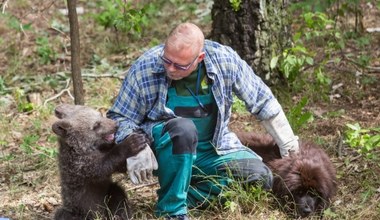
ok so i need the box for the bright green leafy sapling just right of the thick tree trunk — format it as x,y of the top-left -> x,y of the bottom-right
270,12 -> 338,86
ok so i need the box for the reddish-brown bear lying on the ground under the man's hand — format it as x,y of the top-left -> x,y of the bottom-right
237,132 -> 337,217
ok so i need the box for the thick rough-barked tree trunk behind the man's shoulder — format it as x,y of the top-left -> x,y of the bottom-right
210,0 -> 290,83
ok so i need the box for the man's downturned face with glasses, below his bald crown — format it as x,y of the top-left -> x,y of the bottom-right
161,46 -> 204,80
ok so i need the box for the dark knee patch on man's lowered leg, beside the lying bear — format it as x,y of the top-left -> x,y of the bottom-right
221,158 -> 273,190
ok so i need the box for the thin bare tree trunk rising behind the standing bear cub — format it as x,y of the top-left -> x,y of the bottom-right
67,0 -> 84,105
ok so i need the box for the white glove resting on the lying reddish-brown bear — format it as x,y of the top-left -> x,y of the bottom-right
261,110 -> 299,158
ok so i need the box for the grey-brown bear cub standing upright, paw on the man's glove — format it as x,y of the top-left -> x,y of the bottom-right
52,104 -> 147,220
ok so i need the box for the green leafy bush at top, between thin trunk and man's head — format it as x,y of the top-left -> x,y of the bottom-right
94,0 -> 154,36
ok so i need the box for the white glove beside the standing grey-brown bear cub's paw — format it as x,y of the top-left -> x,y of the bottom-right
127,144 -> 158,184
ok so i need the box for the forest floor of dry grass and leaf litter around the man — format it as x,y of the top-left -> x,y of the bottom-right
0,0 -> 380,219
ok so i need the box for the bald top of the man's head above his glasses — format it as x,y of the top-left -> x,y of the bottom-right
165,23 -> 205,54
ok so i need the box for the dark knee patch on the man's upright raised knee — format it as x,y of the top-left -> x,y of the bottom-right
162,118 -> 198,154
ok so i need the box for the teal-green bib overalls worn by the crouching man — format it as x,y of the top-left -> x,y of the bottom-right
153,63 -> 257,217
